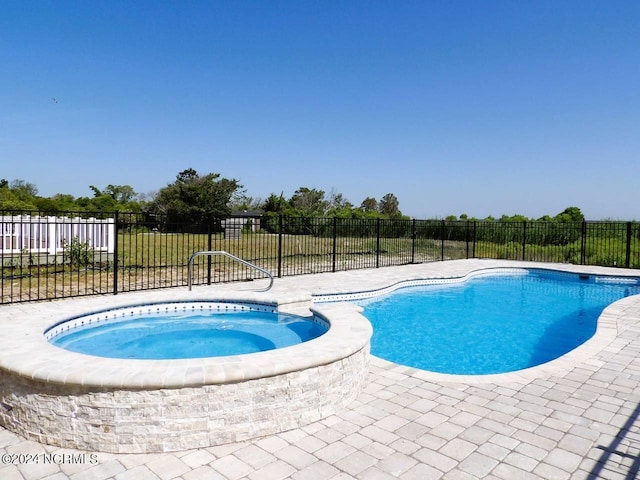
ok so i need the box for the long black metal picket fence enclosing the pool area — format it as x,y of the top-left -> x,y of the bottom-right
0,212 -> 640,303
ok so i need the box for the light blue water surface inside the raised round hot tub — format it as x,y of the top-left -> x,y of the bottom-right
50,311 -> 327,359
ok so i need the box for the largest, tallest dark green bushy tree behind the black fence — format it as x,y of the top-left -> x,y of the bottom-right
151,168 -> 242,224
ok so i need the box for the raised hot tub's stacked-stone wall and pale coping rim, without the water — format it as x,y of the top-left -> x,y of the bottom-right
0,292 -> 372,453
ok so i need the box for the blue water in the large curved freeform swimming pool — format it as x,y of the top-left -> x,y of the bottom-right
358,271 -> 640,375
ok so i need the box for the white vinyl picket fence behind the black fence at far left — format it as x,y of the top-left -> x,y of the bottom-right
0,215 -> 116,255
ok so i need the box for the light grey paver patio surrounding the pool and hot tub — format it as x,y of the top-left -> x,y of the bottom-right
0,260 -> 640,480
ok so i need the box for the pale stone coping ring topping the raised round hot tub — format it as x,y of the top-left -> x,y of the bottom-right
0,289 -> 372,390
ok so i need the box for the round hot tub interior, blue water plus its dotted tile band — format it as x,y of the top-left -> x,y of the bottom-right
45,302 -> 329,360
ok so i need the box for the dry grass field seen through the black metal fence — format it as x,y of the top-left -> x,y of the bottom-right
0,233 -> 464,303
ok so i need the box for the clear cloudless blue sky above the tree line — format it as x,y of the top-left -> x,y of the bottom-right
0,0 -> 640,220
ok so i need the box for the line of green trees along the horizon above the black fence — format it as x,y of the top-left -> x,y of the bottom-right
0,168 -> 596,223
